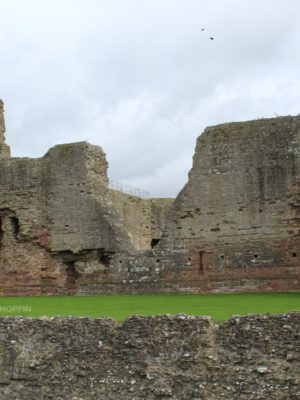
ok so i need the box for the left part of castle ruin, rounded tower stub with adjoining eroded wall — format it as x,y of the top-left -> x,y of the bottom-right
0,143 -> 136,295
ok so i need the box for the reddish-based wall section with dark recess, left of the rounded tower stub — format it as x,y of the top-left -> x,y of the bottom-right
0,159 -> 61,295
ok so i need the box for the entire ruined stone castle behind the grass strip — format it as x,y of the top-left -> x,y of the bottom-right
0,98 -> 300,295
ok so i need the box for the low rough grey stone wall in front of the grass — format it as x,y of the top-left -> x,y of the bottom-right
0,313 -> 300,400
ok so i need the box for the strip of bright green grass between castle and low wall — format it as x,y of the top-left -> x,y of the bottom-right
0,292 -> 300,321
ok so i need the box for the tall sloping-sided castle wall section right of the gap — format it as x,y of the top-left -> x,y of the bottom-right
155,117 -> 300,291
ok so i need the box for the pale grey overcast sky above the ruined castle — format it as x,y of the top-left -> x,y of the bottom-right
0,0 -> 300,197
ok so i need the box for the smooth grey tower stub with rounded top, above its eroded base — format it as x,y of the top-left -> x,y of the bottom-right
45,143 -> 130,253
